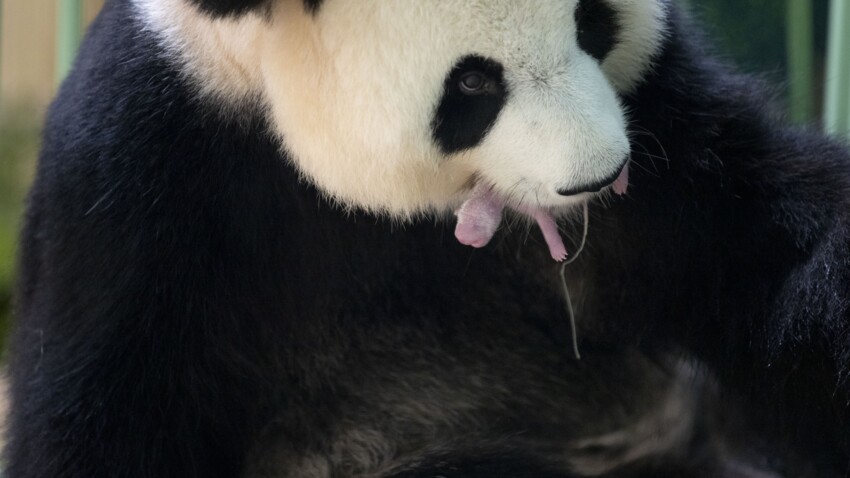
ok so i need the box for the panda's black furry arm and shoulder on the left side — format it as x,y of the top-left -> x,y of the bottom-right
5,2 -> 288,478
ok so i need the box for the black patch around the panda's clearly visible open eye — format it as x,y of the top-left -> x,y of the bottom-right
431,55 -> 508,154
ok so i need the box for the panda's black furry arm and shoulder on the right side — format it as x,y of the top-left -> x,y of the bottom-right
604,7 -> 850,459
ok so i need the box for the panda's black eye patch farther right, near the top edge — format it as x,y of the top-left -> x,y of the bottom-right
575,0 -> 620,61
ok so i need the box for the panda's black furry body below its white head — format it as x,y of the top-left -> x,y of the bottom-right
6,0 -> 850,478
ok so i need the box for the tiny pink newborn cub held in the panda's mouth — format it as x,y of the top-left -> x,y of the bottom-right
455,163 -> 629,262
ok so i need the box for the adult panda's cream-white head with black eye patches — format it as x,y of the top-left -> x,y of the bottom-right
135,0 -> 665,217
